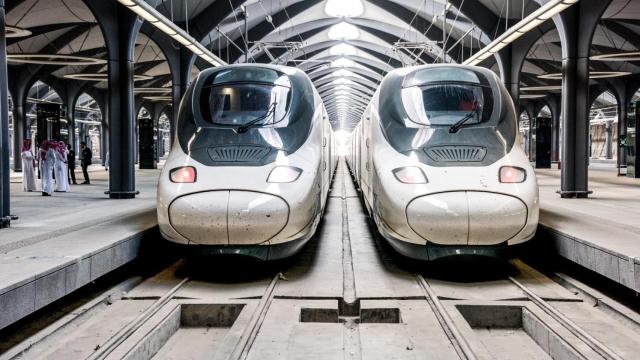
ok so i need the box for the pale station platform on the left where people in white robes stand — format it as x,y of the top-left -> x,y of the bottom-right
0,166 -> 158,329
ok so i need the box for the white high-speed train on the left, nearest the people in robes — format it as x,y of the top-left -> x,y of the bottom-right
157,64 -> 336,260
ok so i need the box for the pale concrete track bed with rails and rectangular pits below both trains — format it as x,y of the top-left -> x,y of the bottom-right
0,165 -> 640,360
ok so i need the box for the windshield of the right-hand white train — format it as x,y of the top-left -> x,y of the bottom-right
402,68 -> 493,126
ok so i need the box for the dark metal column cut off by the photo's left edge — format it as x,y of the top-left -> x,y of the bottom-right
0,0 -> 17,229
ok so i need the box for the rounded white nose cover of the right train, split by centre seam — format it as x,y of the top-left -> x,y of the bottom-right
406,191 -> 527,245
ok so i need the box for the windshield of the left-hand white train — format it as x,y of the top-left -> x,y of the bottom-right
200,70 -> 291,126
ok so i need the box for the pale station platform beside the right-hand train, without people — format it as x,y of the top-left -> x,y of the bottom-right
536,166 -> 640,292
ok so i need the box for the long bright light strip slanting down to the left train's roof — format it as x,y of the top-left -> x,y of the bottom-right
118,0 -> 227,66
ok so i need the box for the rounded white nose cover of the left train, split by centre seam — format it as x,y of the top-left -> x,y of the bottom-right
169,190 -> 289,245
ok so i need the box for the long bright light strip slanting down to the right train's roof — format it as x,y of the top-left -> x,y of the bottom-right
463,0 -> 578,65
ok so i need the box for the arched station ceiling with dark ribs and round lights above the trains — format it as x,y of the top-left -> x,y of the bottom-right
5,0 -> 640,131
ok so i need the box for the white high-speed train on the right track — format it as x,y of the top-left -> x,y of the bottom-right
347,64 -> 539,260
